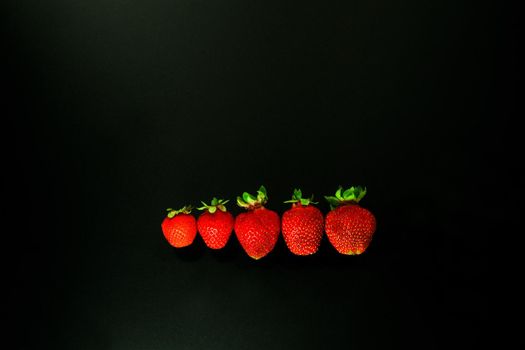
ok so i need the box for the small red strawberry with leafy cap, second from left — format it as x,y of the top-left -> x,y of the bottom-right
197,197 -> 234,249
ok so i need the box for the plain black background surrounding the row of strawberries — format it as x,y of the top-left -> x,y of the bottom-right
2,0 -> 516,349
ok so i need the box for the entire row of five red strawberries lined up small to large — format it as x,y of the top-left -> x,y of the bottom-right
161,186 -> 376,260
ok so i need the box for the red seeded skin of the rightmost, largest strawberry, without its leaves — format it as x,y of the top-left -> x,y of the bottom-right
325,204 -> 376,255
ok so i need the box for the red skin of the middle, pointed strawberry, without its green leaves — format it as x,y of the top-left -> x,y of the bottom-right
234,207 -> 281,260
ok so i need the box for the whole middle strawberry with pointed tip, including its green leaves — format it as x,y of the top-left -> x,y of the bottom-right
235,186 -> 281,260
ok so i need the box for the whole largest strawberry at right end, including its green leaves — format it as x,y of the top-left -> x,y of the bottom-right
325,186 -> 376,255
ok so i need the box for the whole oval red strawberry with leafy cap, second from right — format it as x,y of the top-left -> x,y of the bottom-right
281,190 -> 324,255
